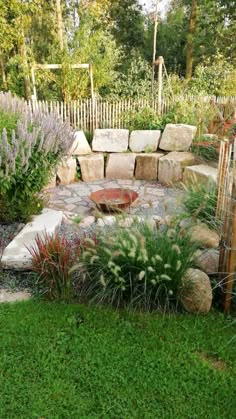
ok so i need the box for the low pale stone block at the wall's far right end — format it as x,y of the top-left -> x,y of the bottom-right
183,164 -> 218,184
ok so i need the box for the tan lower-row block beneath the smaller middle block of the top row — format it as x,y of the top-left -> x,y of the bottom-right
135,153 -> 164,180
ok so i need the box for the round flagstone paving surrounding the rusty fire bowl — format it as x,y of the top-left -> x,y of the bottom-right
46,179 -> 183,217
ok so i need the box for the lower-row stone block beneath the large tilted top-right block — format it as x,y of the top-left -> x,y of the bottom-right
158,151 -> 194,185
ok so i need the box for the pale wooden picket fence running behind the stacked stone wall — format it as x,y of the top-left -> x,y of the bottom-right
30,96 -> 236,132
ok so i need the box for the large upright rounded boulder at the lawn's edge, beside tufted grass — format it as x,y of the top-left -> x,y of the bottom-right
180,268 -> 212,314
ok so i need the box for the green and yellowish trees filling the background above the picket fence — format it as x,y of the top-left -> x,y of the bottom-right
0,0 -> 236,100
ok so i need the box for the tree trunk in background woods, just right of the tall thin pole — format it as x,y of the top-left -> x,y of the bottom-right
185,0 -> 198,80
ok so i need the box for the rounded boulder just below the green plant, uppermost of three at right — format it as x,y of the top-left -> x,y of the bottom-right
189,223 -> 220,249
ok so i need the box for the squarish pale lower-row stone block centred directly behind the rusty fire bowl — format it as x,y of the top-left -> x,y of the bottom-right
106,153 -> 136,179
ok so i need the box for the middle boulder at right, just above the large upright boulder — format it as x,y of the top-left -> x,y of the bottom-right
194,249 -> 219,274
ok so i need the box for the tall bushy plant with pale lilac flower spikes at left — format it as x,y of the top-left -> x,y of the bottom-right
0,94 -> 73,222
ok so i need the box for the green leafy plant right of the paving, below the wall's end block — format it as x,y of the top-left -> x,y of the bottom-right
184,181 -> 219,227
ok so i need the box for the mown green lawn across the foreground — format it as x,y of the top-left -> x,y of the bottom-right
0,301 -> 236,419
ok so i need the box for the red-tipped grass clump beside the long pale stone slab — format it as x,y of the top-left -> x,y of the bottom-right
28,233 -> 80,302
